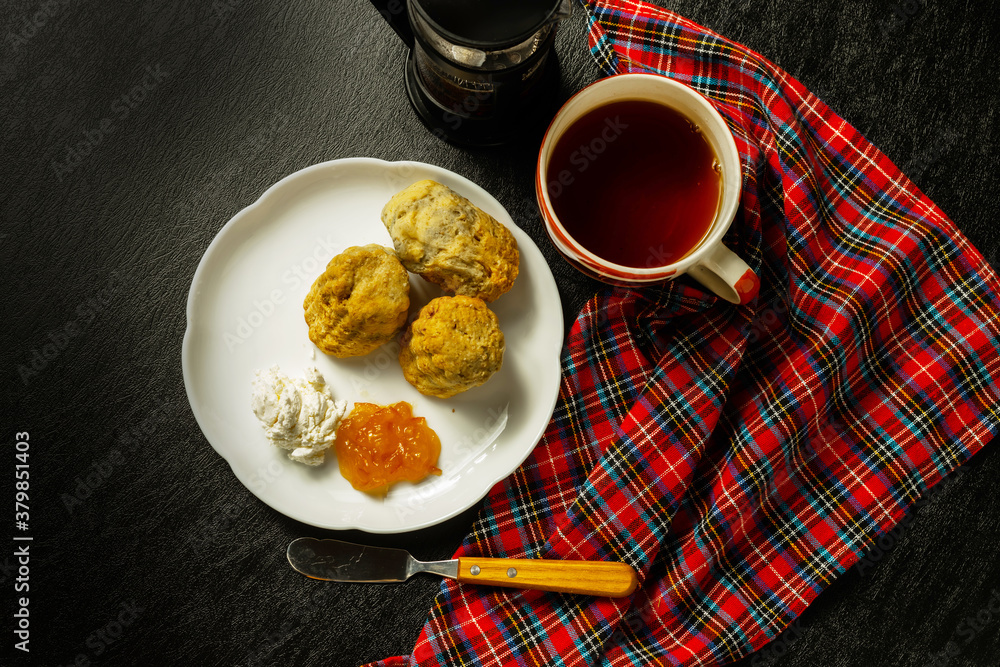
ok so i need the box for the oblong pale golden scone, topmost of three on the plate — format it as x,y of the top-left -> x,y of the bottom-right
382,180 -> 520,301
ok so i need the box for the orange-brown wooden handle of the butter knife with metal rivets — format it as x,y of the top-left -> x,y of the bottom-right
457,556 -> 639,598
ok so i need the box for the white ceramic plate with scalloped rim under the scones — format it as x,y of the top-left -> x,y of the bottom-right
182,158 -> 563,533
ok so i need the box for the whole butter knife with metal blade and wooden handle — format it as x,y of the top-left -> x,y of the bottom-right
287,537 -> 639,598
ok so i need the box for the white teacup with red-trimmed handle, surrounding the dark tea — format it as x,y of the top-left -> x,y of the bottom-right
535,74 -> 760,304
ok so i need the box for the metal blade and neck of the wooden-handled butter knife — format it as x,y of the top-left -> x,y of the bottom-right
287,537 -> 458,583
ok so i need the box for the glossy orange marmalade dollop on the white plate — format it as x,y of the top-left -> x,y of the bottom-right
334,401 -> 441,494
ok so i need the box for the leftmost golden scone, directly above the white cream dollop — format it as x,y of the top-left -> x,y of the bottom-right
302,244 -> 410,358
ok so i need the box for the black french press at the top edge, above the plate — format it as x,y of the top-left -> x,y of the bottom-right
371,0 -> 572,146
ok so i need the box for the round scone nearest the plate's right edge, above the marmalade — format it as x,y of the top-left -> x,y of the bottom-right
399,296 -> 504,398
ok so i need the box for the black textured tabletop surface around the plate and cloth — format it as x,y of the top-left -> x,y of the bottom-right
0,0 -> 1000,666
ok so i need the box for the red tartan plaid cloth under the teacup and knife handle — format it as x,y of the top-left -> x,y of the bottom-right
370,0 -> 1000,665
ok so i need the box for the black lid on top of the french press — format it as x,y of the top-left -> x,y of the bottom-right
411,0 -> 563,50
